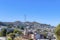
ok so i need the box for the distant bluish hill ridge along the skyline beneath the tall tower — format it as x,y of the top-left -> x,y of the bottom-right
0,21 -> 54,28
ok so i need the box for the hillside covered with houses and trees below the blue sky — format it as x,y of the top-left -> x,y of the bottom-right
0,21 -> 56,40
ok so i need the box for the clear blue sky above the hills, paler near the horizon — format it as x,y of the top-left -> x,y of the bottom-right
0,0 -> 60,26
